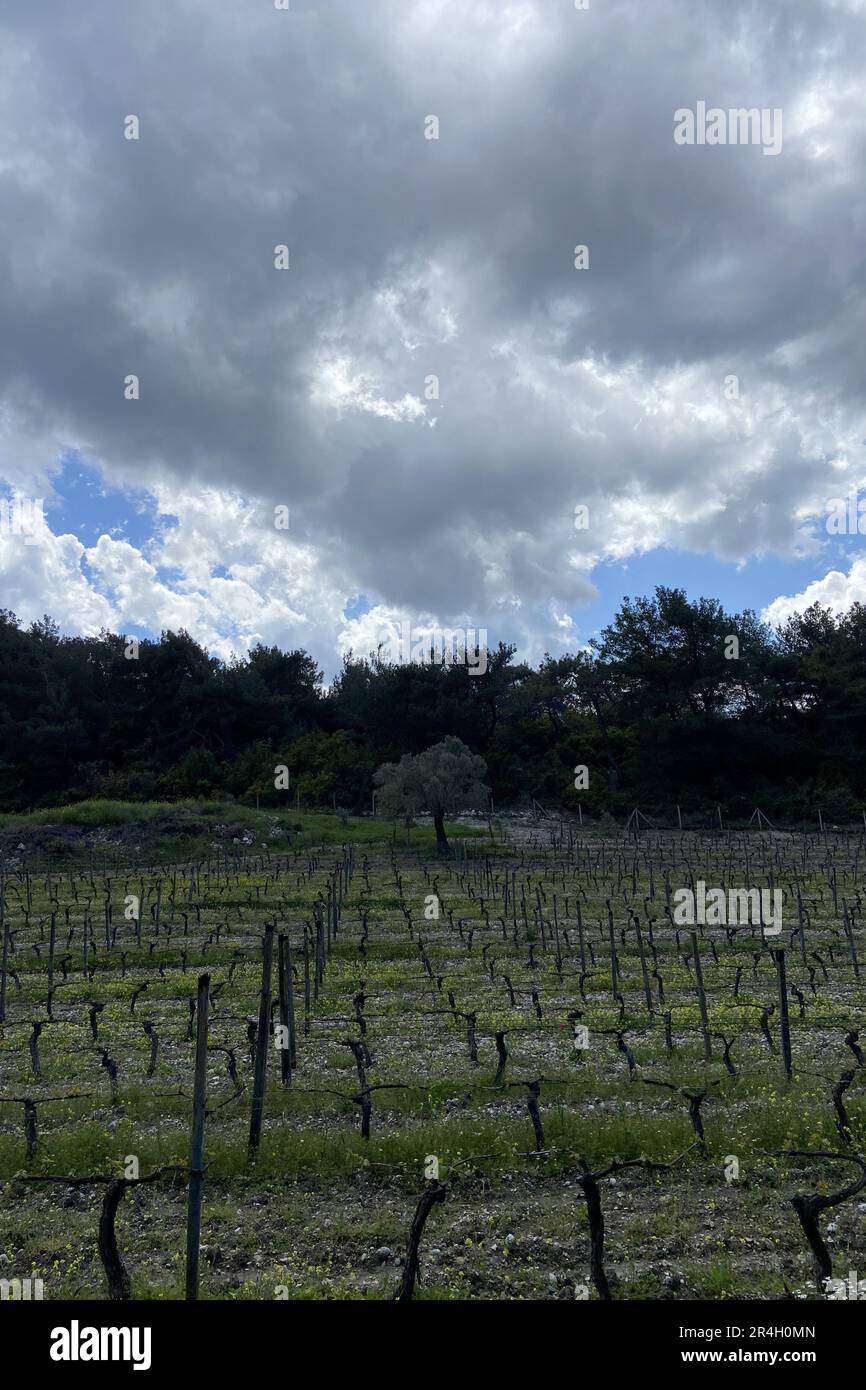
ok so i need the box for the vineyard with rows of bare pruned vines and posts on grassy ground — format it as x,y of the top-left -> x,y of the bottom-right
0,821 -> 866,1300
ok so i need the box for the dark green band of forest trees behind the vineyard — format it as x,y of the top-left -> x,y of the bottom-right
0,588 -> 866,820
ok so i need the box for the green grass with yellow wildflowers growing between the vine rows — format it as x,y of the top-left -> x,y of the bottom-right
0,802 -> 866,1300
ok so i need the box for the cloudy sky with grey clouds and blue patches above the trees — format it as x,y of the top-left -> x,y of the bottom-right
0,0 -> 866,676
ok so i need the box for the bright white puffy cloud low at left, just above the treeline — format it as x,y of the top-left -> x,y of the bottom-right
0,488 -> 594,674
